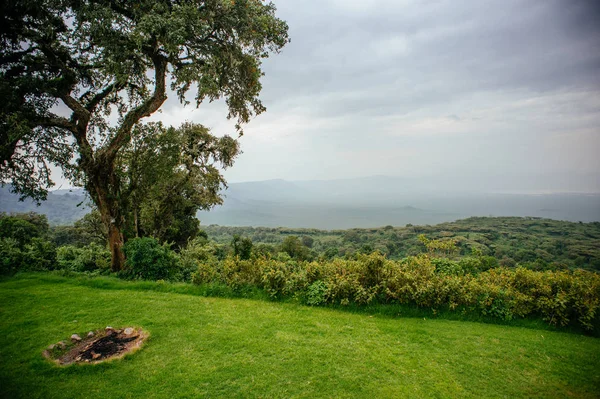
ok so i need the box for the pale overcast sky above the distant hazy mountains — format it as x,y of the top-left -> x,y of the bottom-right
152,0 -> 600,191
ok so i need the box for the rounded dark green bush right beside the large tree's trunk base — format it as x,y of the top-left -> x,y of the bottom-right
121,237 -> 181,280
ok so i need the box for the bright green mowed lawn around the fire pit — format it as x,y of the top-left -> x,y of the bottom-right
0,275 -> 600,398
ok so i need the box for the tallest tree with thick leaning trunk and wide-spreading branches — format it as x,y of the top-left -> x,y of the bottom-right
0,0 -> 289,270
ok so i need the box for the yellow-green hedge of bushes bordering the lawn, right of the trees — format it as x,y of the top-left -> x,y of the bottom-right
193,253 -> 600,330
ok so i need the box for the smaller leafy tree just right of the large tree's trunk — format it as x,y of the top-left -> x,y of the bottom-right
117,122 -> 239,247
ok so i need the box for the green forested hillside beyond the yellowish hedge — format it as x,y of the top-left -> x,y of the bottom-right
206,217 -> 600,271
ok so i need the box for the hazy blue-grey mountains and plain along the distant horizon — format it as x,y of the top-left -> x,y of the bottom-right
0,176 -> 600,229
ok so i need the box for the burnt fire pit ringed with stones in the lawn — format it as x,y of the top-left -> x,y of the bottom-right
43,327 -> 148,366
